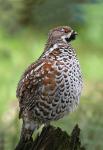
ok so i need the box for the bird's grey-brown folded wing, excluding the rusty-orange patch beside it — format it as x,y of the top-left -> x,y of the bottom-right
16,58 -> 42,117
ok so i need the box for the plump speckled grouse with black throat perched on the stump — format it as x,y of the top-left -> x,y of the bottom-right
16,26 -> 83,140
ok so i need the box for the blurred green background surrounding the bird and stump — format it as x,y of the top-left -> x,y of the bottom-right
0,0 -> 103,150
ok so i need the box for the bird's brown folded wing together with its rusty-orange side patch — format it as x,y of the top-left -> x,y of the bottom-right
17,56 -> 58,117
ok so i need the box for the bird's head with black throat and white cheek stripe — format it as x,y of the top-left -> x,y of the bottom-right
49,26 -> 77,43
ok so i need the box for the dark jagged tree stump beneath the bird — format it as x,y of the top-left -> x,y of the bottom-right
15,125 -> 85,150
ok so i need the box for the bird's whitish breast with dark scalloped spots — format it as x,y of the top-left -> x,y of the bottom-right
55,51 -> 82,111
